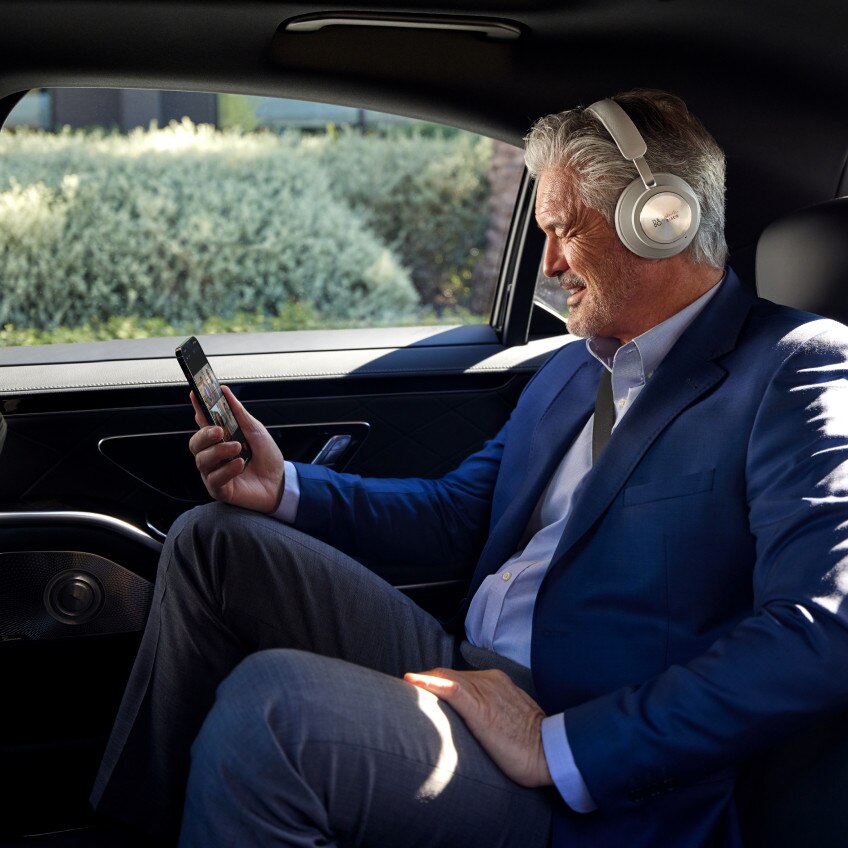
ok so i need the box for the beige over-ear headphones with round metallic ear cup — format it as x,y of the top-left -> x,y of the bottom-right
586,100 -> 701,259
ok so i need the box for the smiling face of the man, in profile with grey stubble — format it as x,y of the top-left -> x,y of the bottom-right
536,170 -> 641,340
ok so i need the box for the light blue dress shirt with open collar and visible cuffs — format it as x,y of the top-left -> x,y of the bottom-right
274,284 -> 719,813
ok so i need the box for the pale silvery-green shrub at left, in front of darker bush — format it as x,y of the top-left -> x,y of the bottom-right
0,122 -> 419,328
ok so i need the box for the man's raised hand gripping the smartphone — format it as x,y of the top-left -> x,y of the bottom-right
188,386 -> 284,513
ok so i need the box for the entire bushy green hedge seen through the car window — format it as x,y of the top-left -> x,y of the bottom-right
0,122 -> 490,337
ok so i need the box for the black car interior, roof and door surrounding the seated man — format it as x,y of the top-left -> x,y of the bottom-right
0,0 -> 848,848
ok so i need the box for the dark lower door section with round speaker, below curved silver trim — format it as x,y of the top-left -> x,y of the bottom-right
0,510 -> 161,839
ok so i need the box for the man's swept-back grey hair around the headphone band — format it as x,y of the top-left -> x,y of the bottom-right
524,89 -> 727,268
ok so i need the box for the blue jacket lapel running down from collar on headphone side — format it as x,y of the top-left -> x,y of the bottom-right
552,269 -> 755,563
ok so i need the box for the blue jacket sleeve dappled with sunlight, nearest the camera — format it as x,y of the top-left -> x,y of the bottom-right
564,322 -> 848,809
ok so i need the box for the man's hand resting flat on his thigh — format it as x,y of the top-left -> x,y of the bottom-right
404,668 -> 553,786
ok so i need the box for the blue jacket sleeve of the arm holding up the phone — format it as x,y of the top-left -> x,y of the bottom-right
288,423 -> 509,580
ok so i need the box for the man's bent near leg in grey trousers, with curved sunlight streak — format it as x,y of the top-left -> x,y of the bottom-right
180,650 -> 550,848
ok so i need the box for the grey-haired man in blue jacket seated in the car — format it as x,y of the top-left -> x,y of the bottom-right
93,92 -> 848,848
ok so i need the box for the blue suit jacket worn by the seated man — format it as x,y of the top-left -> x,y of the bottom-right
297,272 -> 848,848
